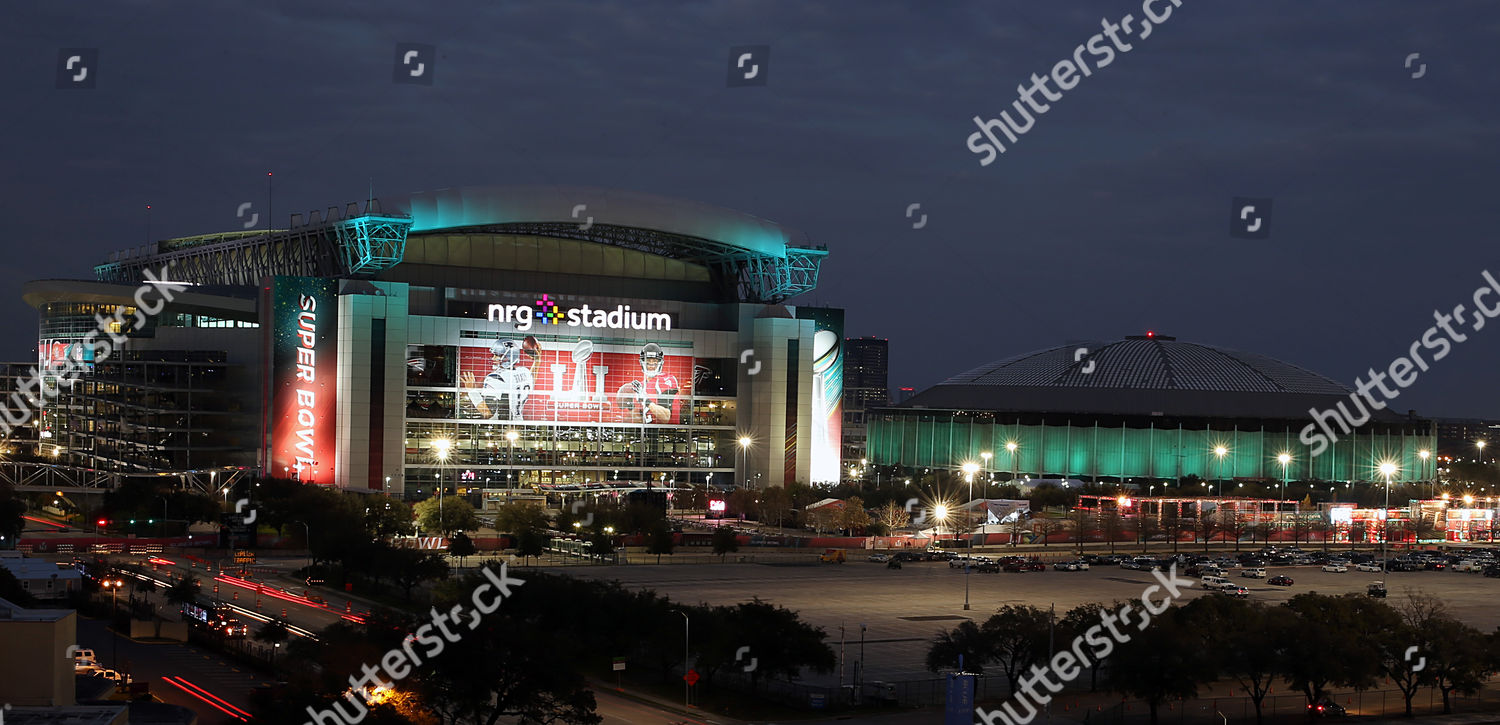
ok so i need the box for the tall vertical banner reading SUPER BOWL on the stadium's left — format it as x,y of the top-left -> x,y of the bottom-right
269,276 -> 339,485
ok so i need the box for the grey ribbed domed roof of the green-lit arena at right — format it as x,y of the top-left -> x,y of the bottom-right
903,335 -> 1395,419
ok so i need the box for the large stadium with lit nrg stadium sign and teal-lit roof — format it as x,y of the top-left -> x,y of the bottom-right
24,186 -> 843,504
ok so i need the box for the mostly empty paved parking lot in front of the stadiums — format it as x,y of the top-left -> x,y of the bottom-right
566,551 -> 1500,683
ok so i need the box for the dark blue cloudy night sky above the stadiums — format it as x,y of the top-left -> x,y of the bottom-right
0,0 -> 1500,417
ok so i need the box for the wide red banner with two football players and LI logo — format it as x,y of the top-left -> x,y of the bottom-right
459,336 -> 693,425
